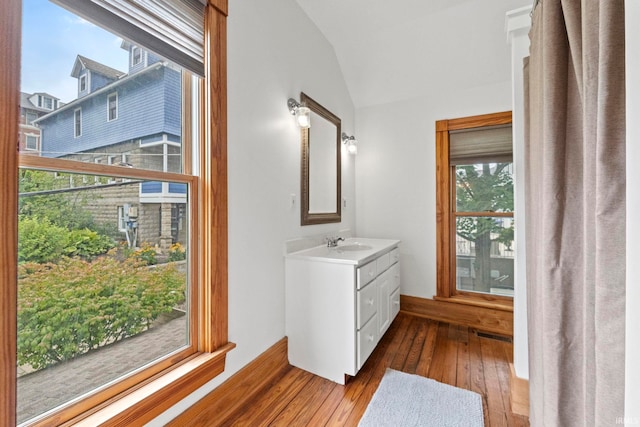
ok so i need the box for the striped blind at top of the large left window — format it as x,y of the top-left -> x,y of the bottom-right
51,0 -> 206,76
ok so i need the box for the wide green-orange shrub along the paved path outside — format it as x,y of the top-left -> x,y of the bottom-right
18,252 -> 186,369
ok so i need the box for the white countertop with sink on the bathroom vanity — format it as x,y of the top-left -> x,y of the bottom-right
285,237 -> 400,265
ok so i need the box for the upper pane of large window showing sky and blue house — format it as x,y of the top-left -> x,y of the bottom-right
21,0 -> 182,172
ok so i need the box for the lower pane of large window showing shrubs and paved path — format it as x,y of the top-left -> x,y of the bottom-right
18,169 -> 189,422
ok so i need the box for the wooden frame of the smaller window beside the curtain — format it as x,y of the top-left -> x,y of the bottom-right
434,111 -> 513,311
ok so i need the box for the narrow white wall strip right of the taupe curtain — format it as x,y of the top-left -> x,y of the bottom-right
625,0 -> 640,425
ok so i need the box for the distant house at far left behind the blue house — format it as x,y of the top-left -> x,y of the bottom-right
19,92 -> 64,156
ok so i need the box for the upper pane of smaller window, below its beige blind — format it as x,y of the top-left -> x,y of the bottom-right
455,163 -> 513,212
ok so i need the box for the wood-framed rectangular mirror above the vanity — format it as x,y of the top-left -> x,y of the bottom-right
300,93 -> 342,225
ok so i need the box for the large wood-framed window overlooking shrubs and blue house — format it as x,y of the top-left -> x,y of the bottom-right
0,0 -> 233,425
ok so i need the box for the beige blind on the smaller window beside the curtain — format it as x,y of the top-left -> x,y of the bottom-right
449,125 -> 513,165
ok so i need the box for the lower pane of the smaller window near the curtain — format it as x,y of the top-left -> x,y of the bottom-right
456,217 -> 515,296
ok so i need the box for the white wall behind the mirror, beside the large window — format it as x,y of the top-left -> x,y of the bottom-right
151,0 -> 355,425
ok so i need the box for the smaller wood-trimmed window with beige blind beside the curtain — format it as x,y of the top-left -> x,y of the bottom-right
436,112 -> 515,304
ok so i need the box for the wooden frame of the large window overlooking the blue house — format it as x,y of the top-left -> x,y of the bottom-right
0,0 -> 235,427
